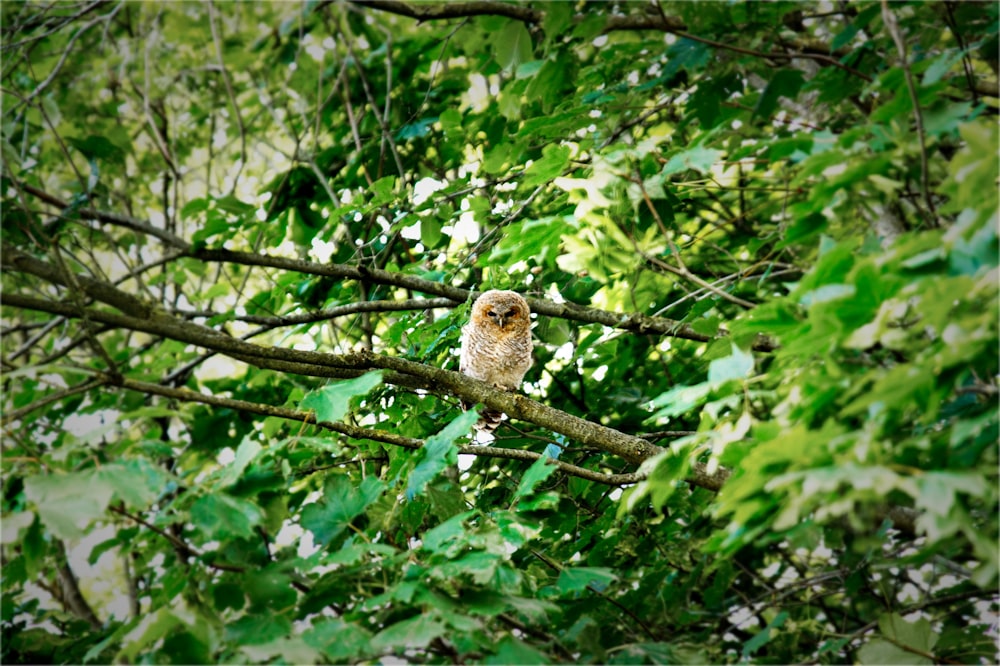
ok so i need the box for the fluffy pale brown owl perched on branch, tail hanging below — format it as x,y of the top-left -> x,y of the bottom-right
458,289 -> 531,432
